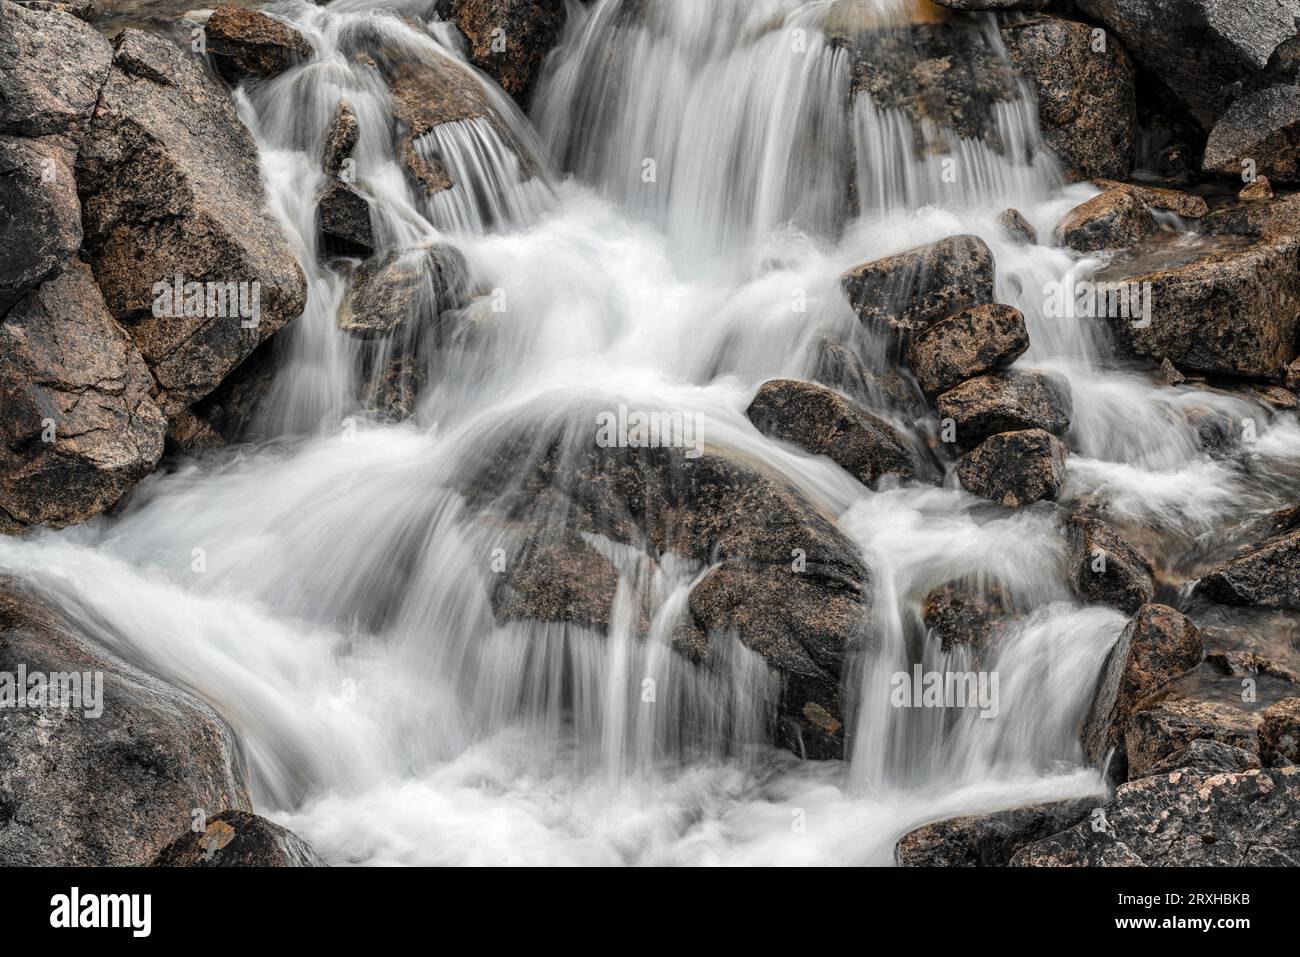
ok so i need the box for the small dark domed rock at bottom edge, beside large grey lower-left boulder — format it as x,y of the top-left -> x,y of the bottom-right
151,810 -> 326,867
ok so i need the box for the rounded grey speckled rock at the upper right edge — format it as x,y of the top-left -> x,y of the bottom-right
1201,86 -> 1300,183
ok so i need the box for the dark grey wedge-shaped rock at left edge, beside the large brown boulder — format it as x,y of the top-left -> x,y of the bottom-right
0,135 -> 82,315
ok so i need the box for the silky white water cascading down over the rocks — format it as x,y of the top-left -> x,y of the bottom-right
0,0 -> 1300,865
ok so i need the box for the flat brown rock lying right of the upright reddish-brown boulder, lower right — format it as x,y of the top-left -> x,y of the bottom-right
1125,700 -> 1260,780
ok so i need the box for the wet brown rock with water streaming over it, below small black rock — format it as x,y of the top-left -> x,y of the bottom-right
338,243 -> 469,339
